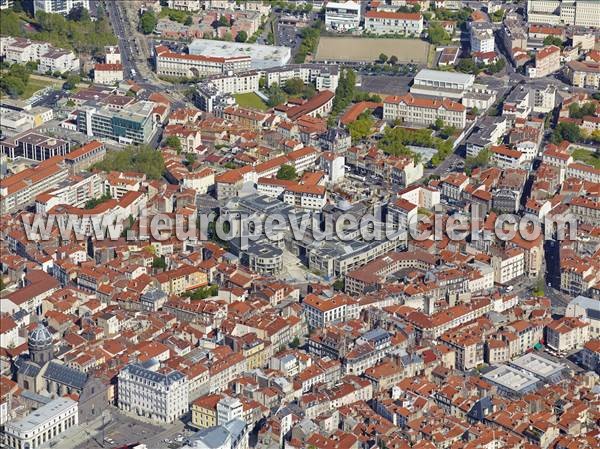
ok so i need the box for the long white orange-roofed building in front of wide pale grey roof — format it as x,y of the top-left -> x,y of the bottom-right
155,46 -> 252,78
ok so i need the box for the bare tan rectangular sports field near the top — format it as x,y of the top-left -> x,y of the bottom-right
316,36 -> 429,64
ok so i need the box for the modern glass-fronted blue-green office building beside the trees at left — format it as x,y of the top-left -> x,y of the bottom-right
77,101 -> 155,144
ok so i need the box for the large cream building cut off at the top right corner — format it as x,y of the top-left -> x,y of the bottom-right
527,0 -> 600,28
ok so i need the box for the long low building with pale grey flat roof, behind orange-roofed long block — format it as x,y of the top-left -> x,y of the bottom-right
188,39 -> 292,71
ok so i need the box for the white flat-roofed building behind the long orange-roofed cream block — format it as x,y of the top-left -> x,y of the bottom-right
410,69 -> 475,99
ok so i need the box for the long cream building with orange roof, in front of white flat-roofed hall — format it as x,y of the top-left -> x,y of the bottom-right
383,93 -> 467,129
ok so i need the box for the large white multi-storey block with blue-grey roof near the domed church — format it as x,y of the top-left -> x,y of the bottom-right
117,361 -> 189,424
